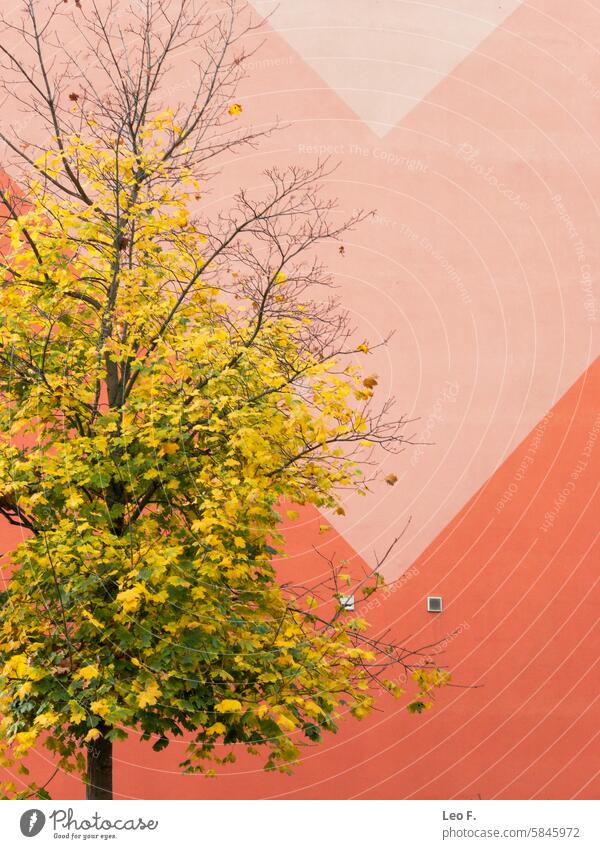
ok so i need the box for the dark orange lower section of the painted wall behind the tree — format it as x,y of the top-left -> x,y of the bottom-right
3,361 -> 600,799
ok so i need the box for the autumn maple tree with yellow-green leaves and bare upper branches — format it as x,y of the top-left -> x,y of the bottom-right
0,0 -> 448,798
